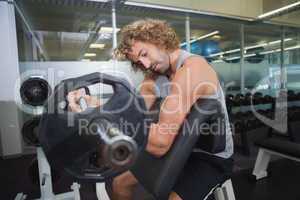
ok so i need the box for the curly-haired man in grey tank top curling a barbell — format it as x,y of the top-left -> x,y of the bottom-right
69,19 -> 233,200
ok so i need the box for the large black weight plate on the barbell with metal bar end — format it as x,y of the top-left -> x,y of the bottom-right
39,73 -> 147,181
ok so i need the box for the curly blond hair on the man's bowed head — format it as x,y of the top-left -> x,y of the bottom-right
114,19 -> 180,70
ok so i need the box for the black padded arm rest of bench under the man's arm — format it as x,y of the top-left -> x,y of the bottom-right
131,99 -> 225,199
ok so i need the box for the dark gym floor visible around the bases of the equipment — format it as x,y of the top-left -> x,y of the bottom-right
0,153 -> 300,200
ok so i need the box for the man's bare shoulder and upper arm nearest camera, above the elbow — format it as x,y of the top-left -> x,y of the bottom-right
159,57 -> 218,133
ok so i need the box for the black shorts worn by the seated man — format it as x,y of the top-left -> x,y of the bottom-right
173,153 -> 233,200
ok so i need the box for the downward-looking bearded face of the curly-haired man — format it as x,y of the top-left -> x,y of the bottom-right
129,41 -> 170,74
